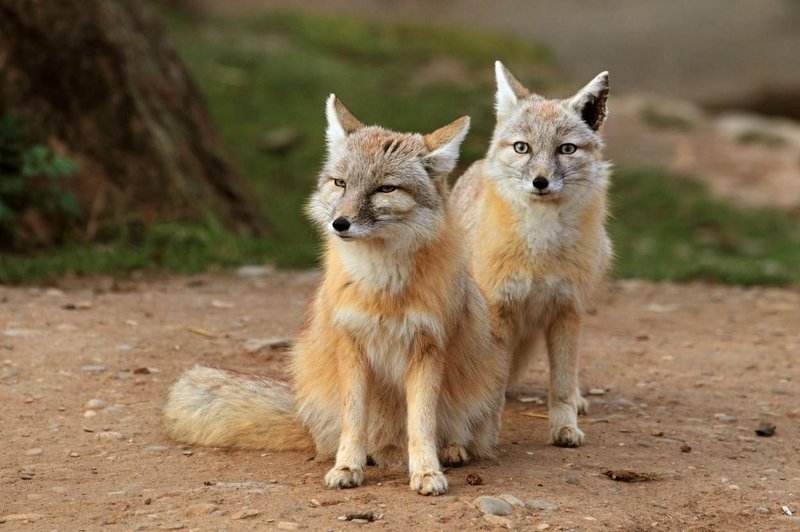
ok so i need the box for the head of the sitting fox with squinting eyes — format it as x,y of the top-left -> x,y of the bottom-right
307,94 -> 469,245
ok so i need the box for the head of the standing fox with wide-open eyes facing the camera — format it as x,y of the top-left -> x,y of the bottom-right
487,61 -> 609,208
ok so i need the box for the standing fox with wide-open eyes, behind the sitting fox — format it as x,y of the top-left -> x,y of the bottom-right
451,61 -> 613,447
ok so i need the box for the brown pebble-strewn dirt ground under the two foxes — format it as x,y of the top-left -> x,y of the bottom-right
0,272 -> 800,530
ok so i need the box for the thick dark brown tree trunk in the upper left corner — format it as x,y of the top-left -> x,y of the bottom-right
0,0 -> 264,237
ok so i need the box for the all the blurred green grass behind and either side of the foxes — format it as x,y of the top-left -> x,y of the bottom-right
0,8 -> 800,284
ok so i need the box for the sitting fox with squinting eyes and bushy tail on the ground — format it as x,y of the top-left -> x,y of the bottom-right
164,95 -> 508,495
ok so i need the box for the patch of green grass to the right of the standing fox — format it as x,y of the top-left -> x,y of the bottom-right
610,169 -> 800,285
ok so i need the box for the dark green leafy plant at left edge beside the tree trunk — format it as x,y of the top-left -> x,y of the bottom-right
0,113 -> 80,247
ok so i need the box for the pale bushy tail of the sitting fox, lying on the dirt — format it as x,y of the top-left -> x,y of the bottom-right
164,366 -> 314,451
